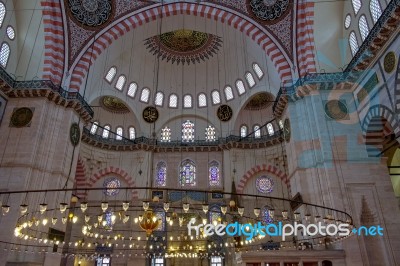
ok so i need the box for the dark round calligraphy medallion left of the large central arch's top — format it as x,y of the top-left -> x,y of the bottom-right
68,0 -> 113,27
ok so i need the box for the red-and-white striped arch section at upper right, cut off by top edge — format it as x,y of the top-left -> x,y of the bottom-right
296,0 -> 317,77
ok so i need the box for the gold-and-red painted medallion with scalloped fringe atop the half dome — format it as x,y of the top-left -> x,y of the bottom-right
144,29 -> 222,65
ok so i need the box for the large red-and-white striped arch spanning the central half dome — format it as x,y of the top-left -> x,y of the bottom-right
70,2 -> 292,91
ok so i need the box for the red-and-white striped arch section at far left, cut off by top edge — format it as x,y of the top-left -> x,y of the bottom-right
41,0 -> 65,84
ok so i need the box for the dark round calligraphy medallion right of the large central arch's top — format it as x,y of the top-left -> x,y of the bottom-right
248,0 -> 290,21
